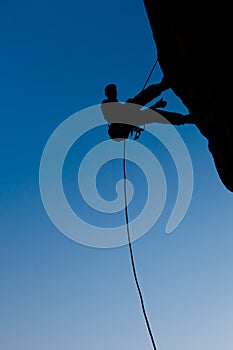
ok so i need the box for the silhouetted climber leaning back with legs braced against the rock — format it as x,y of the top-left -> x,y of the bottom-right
101,79 -> 193,141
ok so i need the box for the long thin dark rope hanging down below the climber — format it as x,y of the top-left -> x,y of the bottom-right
123,140 -> 157,350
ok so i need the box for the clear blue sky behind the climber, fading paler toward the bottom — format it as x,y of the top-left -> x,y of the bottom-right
0,0 -> 233,350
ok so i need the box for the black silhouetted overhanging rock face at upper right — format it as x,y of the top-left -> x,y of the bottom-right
144,0 -> 233,192
